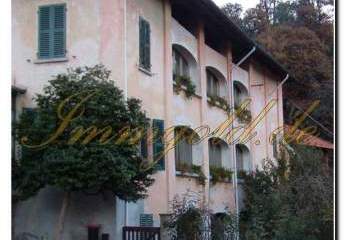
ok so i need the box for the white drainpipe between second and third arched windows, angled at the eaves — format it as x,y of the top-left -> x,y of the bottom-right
230,46 -> 256,240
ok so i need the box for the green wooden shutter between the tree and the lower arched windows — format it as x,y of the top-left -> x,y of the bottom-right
152,119 -> 165,170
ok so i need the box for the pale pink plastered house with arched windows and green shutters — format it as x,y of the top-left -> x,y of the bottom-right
12,0 -> 287,240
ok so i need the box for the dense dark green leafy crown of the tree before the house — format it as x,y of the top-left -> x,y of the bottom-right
13,65 -> 153,201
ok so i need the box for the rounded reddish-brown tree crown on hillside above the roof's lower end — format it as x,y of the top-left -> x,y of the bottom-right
257,26 -> 332,89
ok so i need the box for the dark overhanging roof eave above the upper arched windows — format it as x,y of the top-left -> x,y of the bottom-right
171,0 -> 291,80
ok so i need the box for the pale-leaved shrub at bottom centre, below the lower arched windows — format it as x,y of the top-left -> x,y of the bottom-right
164,191 -> 238,240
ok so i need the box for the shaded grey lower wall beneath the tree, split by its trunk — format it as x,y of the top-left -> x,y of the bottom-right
14,187 -> 118,240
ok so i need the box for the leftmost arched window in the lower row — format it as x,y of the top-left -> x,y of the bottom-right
175,128 -> 193,169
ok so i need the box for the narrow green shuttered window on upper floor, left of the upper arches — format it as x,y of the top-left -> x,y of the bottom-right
139,17 -> 151,71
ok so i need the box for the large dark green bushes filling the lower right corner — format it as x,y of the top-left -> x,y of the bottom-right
240,146 -> 333,240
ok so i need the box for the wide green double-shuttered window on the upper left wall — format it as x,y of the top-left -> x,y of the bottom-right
38,4 -> 66,59
